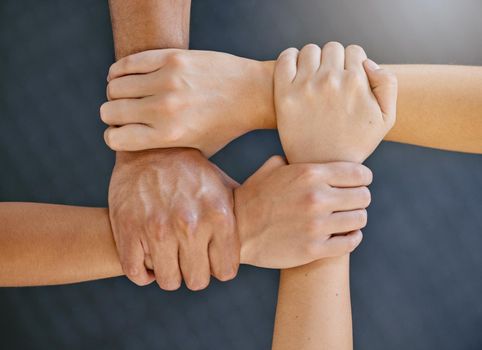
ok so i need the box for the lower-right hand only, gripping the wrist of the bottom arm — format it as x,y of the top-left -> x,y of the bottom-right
234,156 -> 372,269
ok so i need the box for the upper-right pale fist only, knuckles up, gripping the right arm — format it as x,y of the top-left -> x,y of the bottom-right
274,42 -> 397,163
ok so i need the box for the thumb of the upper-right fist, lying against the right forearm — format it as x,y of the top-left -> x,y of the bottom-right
363,59 -> 398,122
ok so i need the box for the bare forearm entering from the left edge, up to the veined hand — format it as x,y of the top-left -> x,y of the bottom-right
0,203 -> 123,286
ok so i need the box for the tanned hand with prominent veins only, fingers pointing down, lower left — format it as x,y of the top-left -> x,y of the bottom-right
109,149 -> 239,290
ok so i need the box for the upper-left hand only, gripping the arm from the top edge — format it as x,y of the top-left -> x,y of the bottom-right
100,49 -> 276,156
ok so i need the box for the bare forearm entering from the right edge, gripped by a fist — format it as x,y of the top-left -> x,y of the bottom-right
253,61 -> 482,153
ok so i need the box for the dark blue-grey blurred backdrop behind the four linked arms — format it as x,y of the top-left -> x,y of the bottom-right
0,0 -> 482,350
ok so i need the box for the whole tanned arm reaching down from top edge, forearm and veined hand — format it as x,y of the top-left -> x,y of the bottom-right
106,0 -> 240,290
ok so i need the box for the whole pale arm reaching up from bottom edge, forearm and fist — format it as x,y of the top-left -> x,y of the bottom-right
273,43 -> 397,350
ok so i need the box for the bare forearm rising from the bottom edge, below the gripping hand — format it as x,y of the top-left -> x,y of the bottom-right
273,256 -> 353,350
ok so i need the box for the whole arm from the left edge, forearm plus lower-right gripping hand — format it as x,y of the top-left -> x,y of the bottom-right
0,161 -> 371,286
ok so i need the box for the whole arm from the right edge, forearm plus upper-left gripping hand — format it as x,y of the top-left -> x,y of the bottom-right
103,50 -> 482,155
